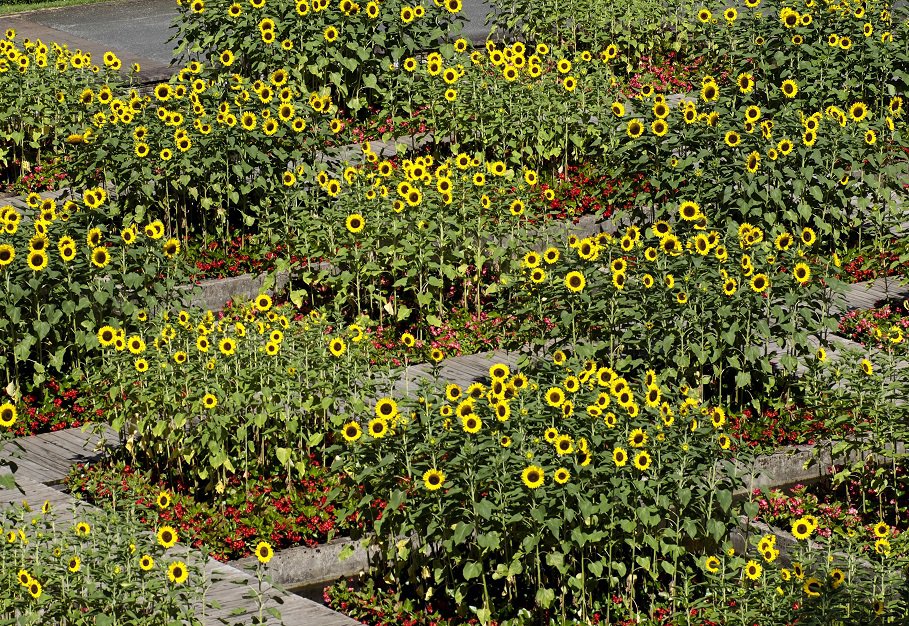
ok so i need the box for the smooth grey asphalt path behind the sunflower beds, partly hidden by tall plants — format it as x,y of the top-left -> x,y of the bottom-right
19,0 -> 490,65
